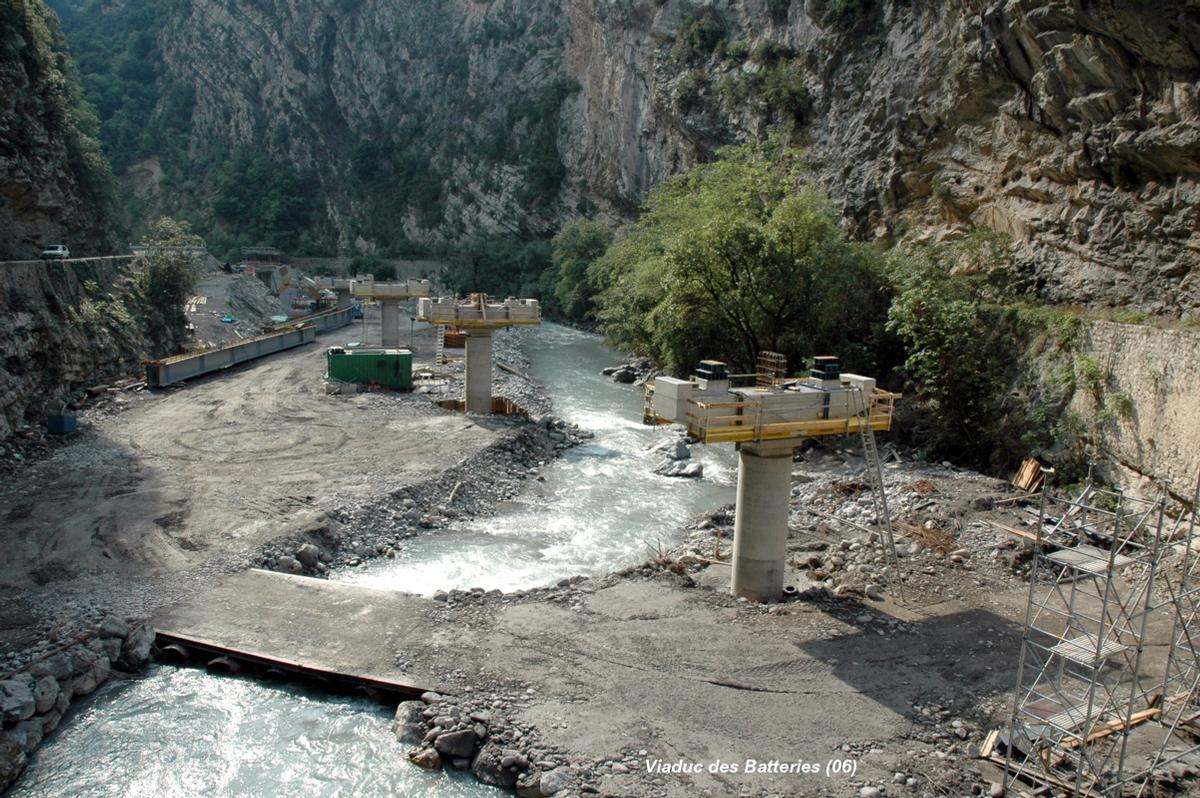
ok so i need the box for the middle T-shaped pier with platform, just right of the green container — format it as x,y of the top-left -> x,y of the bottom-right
416,294 -> 541,414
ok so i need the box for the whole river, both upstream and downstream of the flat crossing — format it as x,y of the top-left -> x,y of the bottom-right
12,325 -> 736,798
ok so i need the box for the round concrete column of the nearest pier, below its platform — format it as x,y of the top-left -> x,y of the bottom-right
730,440 -> 796,601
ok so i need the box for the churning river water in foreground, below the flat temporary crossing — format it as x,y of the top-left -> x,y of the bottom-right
11,666 -> 504,798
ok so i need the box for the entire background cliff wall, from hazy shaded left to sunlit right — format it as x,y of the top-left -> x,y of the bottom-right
124,0 -> 1200,312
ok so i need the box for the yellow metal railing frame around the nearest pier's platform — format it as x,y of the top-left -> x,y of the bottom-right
688,389 -> 900,444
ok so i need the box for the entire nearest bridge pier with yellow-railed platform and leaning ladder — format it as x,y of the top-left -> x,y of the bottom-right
646,353 -> 899,601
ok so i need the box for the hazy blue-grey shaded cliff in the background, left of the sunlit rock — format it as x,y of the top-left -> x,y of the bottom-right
161,0 -> 574,250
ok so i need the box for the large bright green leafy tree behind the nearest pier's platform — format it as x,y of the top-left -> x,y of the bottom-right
589,143 -> 889,372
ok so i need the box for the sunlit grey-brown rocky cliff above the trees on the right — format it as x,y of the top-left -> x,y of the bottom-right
568,0 -> 1200,313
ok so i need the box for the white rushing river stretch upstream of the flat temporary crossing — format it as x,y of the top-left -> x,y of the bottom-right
334,325 -> 737,594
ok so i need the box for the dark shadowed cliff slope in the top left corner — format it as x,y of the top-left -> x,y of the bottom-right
0,0 -> 112,260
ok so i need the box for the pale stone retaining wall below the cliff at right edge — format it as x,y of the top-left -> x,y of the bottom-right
1072,322 -> 1200,498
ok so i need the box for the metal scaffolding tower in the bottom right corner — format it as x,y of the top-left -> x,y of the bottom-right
1002,470 -> 1200,796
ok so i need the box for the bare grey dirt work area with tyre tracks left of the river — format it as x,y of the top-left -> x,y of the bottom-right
0,312 -> 496,587
